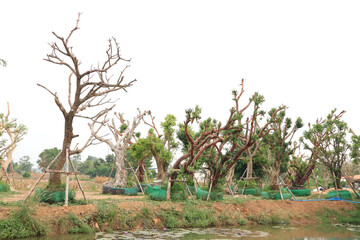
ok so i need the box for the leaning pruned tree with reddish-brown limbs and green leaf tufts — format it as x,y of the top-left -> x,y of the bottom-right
170,81 -> 284,187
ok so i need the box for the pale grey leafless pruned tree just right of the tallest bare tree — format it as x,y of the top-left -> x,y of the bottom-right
89,110 -> 148,188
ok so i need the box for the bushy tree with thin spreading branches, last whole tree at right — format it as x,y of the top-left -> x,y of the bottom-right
304,109 -> 351,188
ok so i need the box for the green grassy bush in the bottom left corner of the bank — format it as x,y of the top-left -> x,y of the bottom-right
0,205 -> 49,239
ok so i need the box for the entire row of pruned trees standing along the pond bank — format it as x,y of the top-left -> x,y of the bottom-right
2,15 -> 360,195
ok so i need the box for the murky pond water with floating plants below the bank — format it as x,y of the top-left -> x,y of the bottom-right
22,224 -> 360,240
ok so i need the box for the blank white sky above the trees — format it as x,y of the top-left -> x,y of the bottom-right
0,0 -> 360,167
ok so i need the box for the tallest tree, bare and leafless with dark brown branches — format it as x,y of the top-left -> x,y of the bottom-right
38,14 -> 136,188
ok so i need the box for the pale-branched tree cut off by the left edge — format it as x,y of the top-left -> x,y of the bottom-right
0,103 -> 27,187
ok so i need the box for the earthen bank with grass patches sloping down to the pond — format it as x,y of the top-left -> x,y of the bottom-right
0,194 -> 360,239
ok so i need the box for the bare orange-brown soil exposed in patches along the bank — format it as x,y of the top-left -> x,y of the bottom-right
0,173 -> 355,235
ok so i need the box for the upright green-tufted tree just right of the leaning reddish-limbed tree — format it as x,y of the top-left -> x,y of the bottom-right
262,108 -> 303,190
